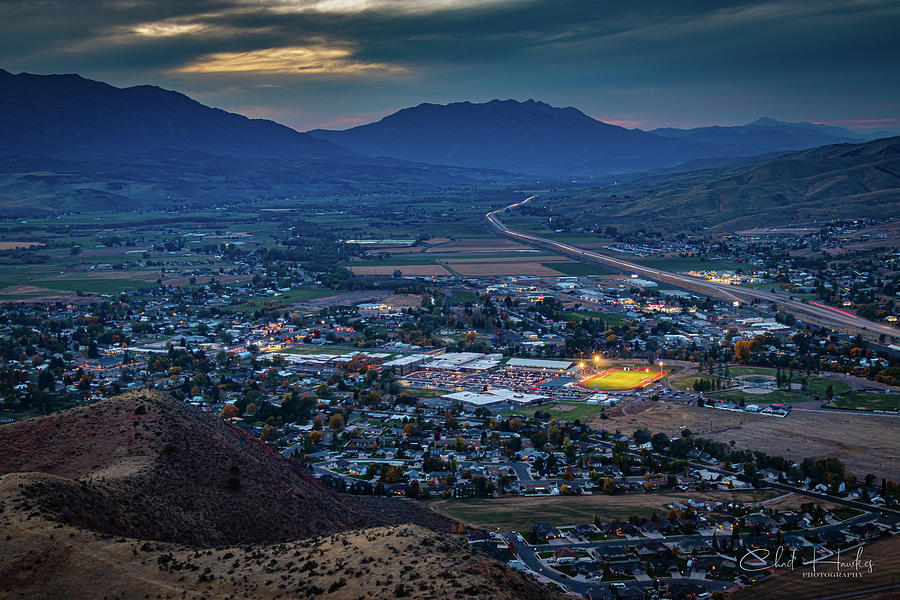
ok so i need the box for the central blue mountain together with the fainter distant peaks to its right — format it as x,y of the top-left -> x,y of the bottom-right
308,100 -> 880,176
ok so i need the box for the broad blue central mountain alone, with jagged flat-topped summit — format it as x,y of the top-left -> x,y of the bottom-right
308,98 -> 719,175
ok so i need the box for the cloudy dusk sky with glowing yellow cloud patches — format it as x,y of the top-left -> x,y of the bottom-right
0,0 -> 900,132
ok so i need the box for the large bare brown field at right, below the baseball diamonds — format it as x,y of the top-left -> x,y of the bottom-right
590,402 -> 900,481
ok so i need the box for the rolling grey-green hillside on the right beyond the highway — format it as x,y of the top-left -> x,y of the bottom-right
558,137 -> 900,230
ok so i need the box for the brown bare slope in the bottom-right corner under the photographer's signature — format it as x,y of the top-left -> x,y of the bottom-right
731,536 -> 900,600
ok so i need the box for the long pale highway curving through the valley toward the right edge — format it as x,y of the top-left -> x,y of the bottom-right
485,196 -> 900,341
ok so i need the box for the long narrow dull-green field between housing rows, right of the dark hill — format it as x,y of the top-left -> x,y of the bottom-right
428,490 -> 780,531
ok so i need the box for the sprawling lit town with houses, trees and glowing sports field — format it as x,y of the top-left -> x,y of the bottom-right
0,213 -> 900,598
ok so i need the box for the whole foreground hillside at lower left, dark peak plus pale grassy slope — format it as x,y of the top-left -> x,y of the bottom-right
0,392 -> 561,600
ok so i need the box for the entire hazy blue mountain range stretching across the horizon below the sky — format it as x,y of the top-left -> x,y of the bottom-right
0,70 -> 892,223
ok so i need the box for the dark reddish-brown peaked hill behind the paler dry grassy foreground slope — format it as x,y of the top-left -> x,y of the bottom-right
0,392 -> 449,545
